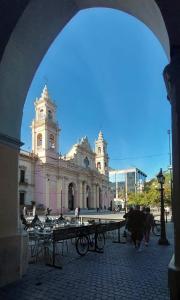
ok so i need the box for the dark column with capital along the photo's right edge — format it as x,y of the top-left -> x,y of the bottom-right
163,53 -> 180,300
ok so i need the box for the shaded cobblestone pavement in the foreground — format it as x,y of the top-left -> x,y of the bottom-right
0,223 -> 173,300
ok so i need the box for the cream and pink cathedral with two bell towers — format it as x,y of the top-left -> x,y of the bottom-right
19,86 -> 113,213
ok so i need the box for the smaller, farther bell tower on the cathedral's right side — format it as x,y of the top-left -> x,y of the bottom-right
95,131 -> 109,176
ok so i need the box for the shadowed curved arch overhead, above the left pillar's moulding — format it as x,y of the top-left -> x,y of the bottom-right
0,0 -> 173,139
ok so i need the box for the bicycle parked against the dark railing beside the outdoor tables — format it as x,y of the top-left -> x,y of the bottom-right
76,232 -> 105,256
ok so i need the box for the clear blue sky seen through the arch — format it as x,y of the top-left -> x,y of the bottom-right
21,8 -> 171,178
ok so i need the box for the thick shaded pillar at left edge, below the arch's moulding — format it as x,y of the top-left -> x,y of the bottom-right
0,134 -> 28,286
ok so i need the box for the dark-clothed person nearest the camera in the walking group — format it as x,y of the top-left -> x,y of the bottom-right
128,205 -> 145,252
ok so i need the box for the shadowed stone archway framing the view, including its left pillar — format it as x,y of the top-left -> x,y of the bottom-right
0,0 -> 169,285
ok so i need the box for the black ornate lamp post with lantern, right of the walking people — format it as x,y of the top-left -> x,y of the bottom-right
157,168 -> 169,245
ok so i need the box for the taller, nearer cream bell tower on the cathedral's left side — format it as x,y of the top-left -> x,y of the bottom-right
31,85 -> 60,162
